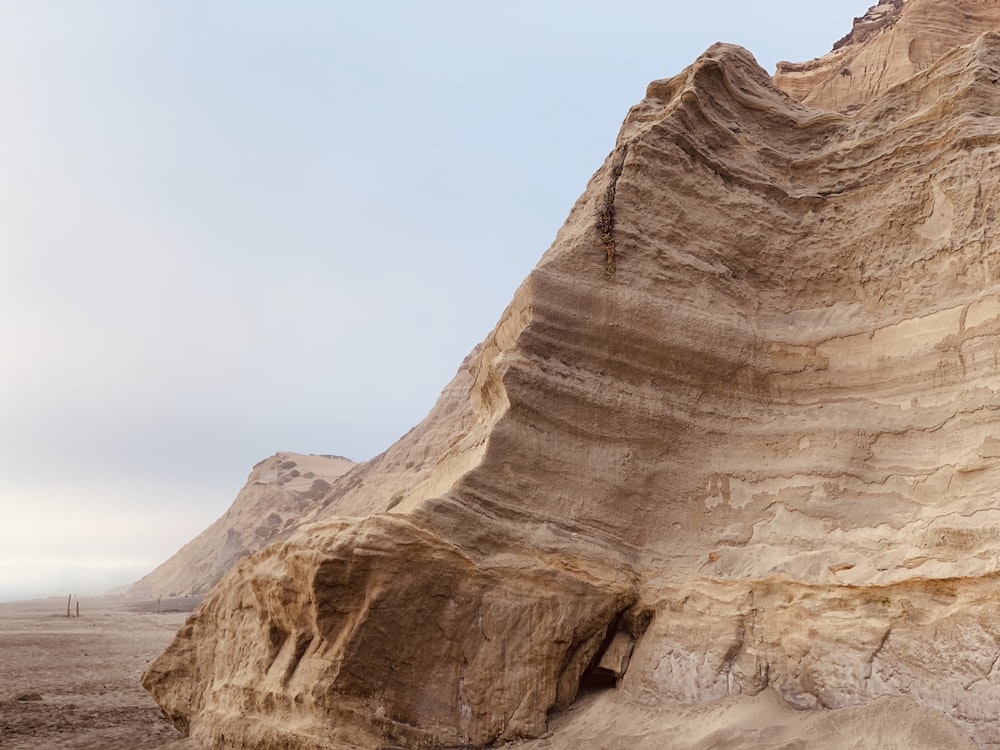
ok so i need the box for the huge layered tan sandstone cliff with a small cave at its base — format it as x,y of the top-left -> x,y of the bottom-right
143,0 -> 1000,750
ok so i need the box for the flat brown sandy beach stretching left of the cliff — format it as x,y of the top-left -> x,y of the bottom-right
0,599 -> 201,750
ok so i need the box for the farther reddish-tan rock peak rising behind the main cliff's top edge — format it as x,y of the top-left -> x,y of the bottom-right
774,0 -> 1000,111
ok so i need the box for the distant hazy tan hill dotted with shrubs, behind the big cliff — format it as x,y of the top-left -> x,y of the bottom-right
125,453 -> 354,596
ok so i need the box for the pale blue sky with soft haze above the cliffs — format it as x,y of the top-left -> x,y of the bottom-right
0,0 -> 870,600
